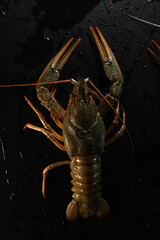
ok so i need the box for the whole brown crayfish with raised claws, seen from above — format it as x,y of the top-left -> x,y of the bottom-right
25,27 -> 125,220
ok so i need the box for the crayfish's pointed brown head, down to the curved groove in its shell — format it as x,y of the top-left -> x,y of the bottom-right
67,79 -> 97,130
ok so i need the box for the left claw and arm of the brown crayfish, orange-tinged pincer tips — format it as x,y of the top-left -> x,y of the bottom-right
36,38 -> 81,120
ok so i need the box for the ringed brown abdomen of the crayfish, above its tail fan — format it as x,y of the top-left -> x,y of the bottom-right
71,156 -> 101,204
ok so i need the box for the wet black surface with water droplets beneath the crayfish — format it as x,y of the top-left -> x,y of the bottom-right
0,0 -> 160,240
